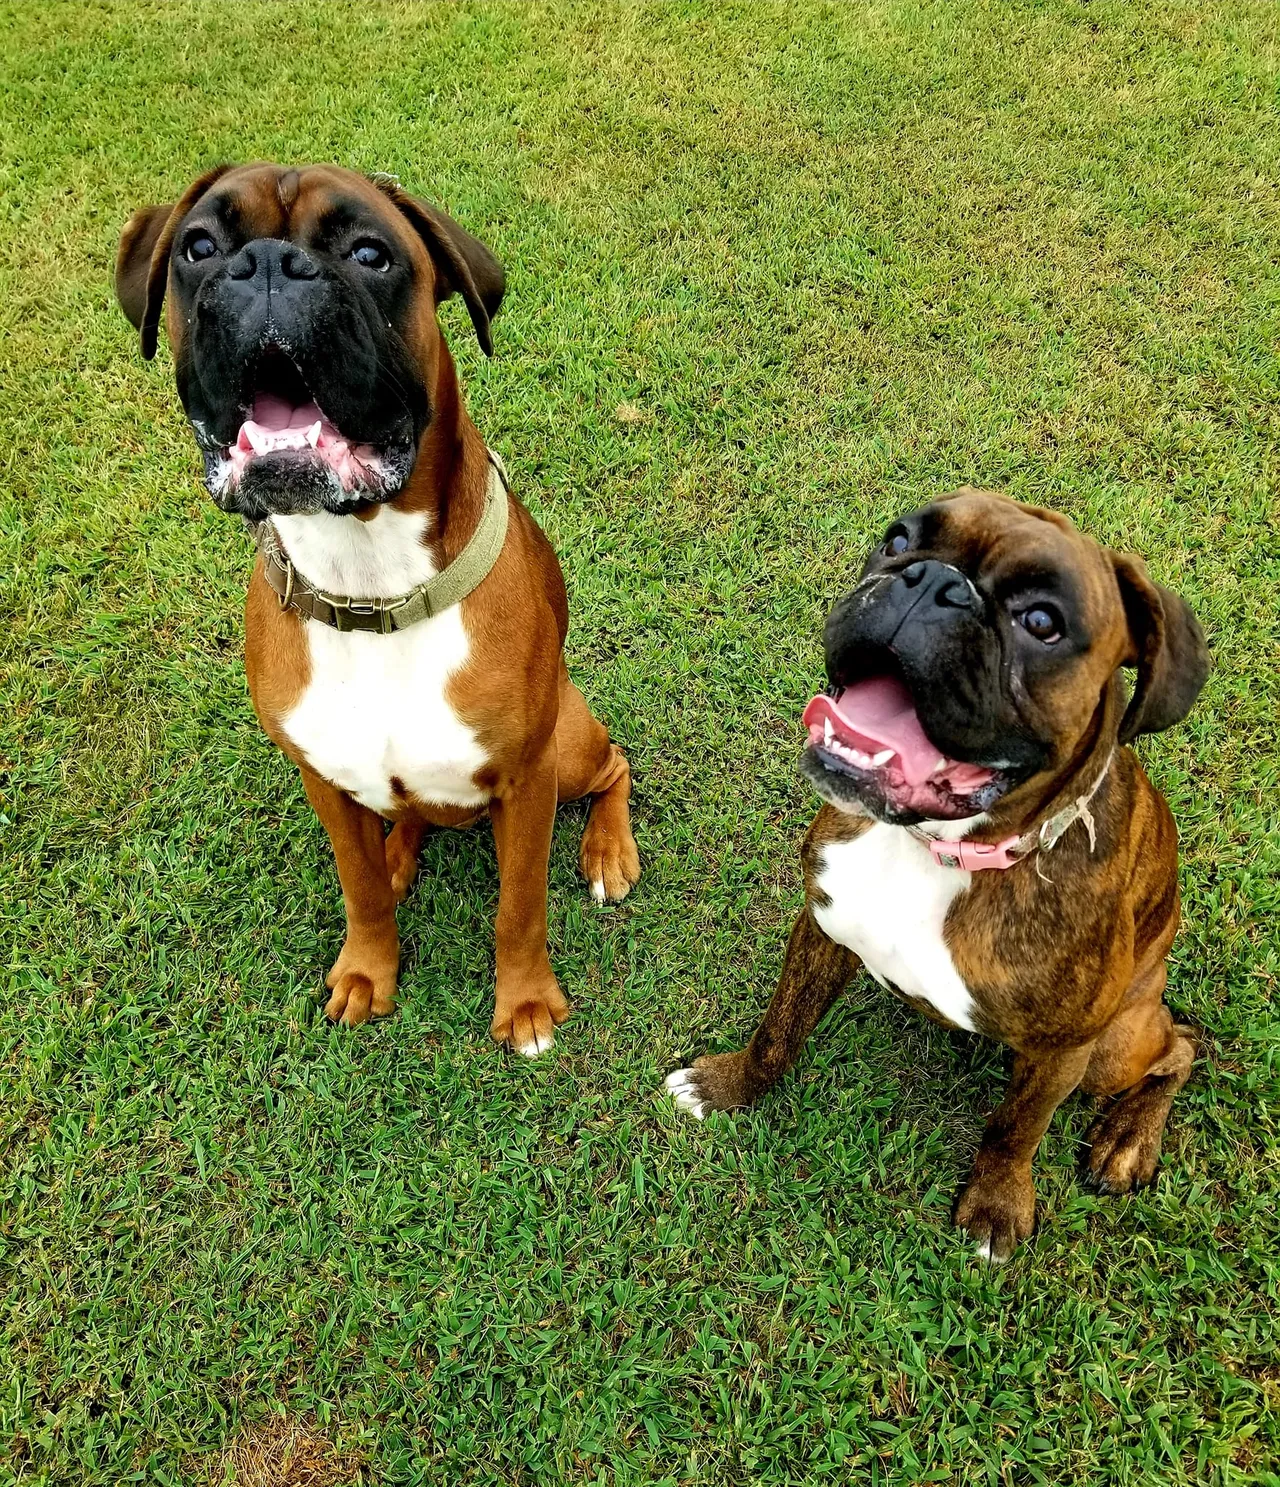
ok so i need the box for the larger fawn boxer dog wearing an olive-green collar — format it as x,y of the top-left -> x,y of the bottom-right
116,165 -> 639,1056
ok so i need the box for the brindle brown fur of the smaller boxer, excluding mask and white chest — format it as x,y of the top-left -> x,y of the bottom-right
674,491 -> 1207,1259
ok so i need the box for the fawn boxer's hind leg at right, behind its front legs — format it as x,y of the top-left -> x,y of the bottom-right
556,668 -> 639,903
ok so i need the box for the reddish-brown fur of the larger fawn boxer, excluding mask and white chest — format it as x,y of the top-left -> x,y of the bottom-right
117,165 -> 639,1044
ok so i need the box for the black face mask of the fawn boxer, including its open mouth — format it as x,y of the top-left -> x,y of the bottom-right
174,226 -> 431,519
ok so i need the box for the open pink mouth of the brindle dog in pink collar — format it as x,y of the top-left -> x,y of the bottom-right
804,675 -> 1011,821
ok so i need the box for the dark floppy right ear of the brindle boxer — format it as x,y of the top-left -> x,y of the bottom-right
1111,553 -> 1213,744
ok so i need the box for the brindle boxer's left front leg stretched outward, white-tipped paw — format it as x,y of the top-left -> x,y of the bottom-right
666,906 -> 862,1120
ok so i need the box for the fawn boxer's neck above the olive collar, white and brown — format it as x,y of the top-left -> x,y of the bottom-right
274,341 -> 491,599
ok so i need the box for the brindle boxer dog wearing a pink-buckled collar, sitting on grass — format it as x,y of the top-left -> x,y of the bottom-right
668,489 -> 1209,1259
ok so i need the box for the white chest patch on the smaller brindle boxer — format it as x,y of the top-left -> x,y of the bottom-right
813,822 -> 974,1032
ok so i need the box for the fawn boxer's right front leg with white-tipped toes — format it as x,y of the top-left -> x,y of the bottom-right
489,739 -> 569,1059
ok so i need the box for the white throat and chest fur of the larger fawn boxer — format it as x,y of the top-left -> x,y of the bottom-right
275,507 -> 488,812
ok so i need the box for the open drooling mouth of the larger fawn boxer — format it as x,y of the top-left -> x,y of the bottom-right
196,349 -> 412,516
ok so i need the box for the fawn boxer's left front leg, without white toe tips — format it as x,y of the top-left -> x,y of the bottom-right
302,767 -> 400,1026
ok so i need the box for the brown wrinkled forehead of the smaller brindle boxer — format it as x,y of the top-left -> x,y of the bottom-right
908,488 -> 1122,623
